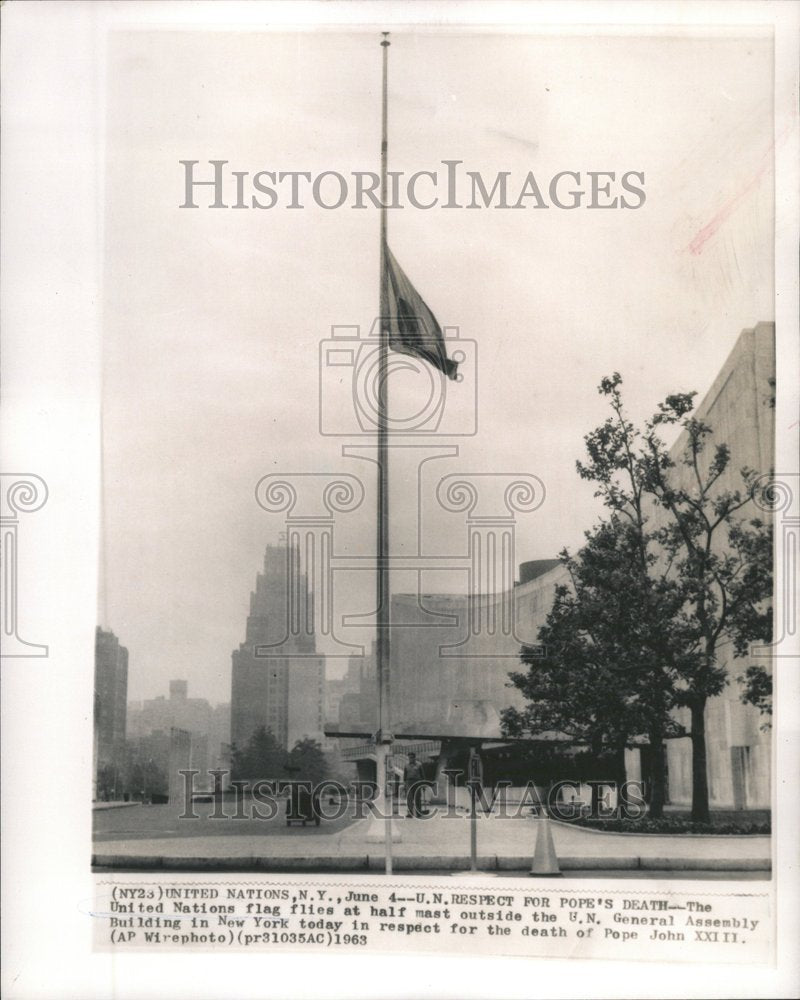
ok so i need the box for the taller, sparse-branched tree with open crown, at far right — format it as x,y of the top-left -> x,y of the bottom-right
577,373 -> 772,822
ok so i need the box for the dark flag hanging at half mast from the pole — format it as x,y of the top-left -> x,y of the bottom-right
381,244 -> 458,379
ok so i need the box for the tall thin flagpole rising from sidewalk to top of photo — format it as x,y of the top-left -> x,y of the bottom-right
375,31 -> 393,875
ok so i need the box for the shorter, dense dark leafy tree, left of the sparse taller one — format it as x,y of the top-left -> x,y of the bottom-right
503,513 -> 680,816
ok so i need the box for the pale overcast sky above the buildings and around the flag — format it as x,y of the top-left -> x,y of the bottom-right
99,29 -> 774,702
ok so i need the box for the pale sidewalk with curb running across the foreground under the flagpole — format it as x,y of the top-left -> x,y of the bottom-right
92,815 -> 771,872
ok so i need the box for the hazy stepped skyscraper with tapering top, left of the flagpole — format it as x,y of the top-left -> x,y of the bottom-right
231,545 -> 325,749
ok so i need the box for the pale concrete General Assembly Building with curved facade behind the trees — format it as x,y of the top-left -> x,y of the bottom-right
360,323 -> 775,808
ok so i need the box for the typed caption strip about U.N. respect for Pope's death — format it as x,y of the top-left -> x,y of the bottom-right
92,876 -> 772,964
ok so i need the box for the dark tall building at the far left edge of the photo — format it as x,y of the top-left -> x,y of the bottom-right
94,626 -> 128,798
